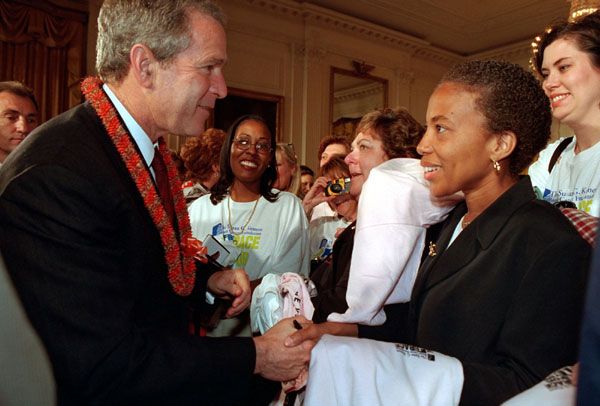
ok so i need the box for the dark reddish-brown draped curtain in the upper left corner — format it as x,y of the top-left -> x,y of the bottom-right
0,0 -> 87,122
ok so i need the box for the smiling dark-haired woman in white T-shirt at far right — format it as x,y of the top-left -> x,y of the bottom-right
529,11 -> 600,216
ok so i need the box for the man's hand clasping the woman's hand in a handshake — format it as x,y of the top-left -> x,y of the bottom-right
254,316 -> 315,381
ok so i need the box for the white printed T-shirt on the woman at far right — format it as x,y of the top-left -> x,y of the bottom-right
529,137 -> 600,216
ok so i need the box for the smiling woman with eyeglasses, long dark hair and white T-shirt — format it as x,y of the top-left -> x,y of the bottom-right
189,115 -> 309,336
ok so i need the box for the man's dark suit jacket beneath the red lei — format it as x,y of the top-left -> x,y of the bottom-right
0,103 -> 255,405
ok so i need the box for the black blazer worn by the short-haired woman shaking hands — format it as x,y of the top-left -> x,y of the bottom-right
360,177 -> 590,405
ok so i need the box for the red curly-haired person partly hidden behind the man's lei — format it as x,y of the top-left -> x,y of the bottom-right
181,128 -> 225,207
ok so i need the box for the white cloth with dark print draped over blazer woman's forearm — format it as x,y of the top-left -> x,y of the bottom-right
304,335 -> 464,406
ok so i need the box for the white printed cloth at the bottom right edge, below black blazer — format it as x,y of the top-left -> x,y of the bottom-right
502,366 -> 577,406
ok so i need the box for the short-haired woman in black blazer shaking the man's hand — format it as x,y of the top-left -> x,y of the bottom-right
291,61 -> 590,404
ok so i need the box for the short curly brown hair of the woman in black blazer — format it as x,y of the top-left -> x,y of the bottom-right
438,61 -> 552,176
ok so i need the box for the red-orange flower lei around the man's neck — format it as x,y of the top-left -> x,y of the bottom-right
81,77 -> 196,296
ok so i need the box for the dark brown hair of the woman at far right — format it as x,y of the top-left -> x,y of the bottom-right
533,10 -> 600,75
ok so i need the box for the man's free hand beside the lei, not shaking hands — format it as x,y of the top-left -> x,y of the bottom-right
207,269 -> 252,318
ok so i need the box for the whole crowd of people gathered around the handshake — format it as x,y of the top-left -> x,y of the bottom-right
0,0 -> 600,405
